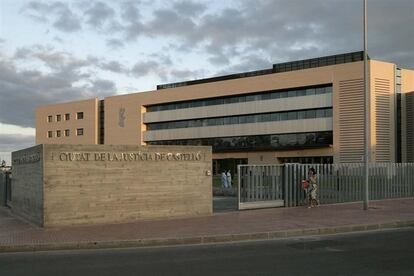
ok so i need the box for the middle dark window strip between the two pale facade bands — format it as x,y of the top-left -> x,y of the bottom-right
147,108 -> 332,130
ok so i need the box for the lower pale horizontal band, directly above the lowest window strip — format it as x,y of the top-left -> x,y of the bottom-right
144,118 -> 332,141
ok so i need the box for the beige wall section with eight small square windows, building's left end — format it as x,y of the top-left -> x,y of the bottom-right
36,99 -> 98,145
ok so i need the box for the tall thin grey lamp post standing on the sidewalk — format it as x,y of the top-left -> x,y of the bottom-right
364,0 -> 371,210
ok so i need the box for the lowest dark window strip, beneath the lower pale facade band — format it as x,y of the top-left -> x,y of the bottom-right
147,131 -> 333,152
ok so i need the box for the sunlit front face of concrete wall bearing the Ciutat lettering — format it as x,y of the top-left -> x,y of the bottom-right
13,145 -> 212,226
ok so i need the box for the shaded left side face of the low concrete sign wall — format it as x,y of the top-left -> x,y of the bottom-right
11,145 -> 43,225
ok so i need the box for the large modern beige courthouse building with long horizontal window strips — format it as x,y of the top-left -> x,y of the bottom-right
36,52 -> 414,172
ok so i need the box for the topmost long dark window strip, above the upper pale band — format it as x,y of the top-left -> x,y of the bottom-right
147,85 -> 332,112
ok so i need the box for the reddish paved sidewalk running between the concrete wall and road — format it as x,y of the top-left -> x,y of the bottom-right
0,198 -> 414,252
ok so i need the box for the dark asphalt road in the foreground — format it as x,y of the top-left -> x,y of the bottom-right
0,228 -> 414,276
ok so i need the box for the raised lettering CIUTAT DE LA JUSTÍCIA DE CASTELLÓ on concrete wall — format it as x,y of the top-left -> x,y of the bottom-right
52,151 -> 203,162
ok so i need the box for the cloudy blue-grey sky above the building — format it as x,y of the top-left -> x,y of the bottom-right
0,0 -> 414,162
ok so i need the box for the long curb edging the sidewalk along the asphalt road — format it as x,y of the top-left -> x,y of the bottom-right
0,220 -> 414,253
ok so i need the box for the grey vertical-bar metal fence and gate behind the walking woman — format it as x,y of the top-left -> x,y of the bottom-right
239,163 -> 414,209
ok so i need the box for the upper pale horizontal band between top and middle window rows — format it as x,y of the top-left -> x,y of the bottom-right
143,94 -> 332,123
